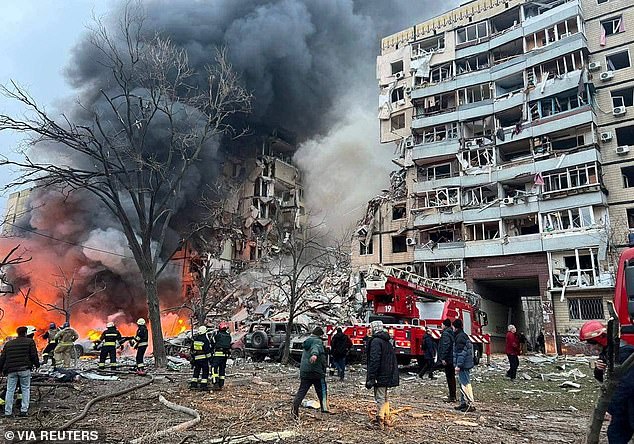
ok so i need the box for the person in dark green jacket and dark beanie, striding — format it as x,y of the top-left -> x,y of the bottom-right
291,327 -> 329,419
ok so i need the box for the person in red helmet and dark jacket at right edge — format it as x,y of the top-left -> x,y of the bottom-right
579,320 -> 634,444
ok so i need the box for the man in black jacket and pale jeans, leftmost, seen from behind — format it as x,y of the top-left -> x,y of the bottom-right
0,327 -> 40,417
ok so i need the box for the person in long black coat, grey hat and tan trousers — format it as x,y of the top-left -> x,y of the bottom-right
365,321 -> 399,424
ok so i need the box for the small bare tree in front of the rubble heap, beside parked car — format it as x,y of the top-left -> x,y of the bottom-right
267,222 -> 350,364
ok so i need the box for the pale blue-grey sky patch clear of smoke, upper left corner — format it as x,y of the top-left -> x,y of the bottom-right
0,0 -> 107,214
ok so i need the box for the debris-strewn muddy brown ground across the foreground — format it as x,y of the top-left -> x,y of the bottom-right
0,356 -> 599,444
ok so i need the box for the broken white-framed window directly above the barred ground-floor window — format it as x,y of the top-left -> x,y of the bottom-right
550,248 -> 600,288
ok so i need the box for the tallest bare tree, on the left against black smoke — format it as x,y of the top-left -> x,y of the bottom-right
0,5 -> 251,367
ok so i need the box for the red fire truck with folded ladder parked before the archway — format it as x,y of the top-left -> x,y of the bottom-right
327,265 -> 491,365
